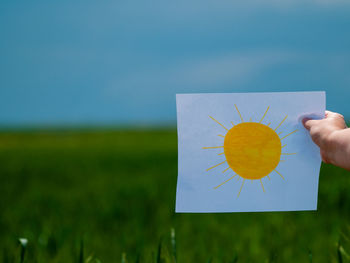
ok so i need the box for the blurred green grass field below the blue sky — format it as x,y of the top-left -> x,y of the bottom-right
0,130 -> 350,263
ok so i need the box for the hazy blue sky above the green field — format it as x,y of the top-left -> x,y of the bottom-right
0,0 -> 350,126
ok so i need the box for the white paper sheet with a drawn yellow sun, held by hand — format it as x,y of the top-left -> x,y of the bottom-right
176,92 -> 325,213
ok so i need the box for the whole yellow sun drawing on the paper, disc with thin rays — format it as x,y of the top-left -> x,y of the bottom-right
203,104 -> 298,197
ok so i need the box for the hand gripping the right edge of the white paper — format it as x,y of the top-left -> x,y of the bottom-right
303,111 -> 350,170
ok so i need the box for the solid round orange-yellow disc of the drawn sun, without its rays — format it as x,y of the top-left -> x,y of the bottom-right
224,122 -> 282,179
